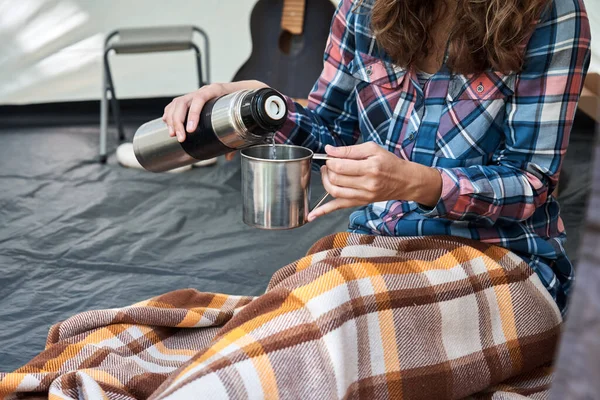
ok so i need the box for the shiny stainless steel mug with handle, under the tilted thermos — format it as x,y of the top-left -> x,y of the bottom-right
241,144 -> 328,230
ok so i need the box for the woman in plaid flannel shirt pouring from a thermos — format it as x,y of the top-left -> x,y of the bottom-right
163,0 -> 590,312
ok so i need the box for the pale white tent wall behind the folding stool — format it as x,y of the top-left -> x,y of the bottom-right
0,0 -> 338,104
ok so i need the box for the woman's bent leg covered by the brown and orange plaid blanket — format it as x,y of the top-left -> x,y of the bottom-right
152,234 -> 561,400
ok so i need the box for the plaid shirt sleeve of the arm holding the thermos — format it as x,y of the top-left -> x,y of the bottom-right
275,0 -> 359,152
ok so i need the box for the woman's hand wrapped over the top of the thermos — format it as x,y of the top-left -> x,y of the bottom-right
162,81 -> 267,143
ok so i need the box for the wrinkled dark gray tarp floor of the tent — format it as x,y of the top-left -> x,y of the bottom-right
0,112 -> 593,372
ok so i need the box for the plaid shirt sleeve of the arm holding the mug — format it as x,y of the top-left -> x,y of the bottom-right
423,0 -> 590,223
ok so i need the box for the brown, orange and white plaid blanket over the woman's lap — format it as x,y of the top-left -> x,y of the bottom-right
0,233 -> 561,400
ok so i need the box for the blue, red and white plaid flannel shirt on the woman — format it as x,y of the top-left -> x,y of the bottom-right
276,0 -> 590,311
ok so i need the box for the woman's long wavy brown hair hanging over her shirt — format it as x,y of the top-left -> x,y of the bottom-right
359,0 -> 550,75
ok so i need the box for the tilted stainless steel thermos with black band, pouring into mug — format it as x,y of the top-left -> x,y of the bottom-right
133,88 -> 287,172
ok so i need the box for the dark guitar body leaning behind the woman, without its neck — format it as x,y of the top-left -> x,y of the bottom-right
233,0 -> 335,99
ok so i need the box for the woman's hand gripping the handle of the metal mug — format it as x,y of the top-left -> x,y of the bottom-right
308,142 -> 442,221
